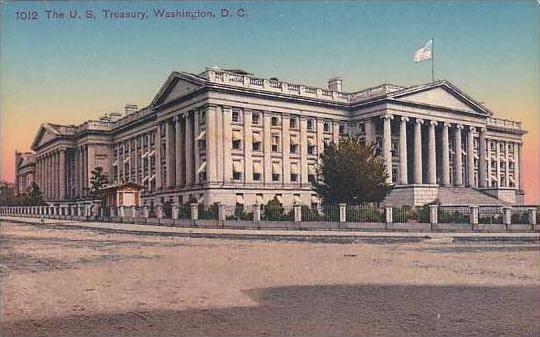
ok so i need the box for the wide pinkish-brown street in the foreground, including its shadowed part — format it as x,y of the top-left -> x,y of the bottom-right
0,222 -> 540,336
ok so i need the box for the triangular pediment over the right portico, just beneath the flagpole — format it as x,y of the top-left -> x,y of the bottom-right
393,83 -> 491,116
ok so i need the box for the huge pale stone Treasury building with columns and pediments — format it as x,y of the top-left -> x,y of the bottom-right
23,68 -> 525,205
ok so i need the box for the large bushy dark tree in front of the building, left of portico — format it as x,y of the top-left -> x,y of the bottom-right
313,137 -> 391,205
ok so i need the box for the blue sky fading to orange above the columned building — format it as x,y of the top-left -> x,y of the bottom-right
0,1 -> 540,204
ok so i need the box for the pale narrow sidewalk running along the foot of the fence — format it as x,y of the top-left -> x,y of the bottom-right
4,216 -> 540,242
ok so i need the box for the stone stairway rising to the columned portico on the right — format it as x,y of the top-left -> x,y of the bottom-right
438,187 -> 510,206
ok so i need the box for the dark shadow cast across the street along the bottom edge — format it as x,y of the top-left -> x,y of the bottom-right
2,285 -> 540,336
